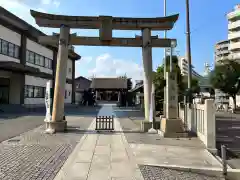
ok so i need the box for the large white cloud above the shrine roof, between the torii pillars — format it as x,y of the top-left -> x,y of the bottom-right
86,53 -> 143,81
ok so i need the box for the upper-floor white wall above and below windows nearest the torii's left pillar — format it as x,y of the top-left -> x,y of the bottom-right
26,39 -> 53,74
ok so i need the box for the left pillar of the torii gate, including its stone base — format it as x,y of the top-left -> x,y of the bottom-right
46,25 -> 70,133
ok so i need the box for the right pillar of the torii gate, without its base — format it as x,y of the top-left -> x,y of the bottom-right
142,28 -> 152,120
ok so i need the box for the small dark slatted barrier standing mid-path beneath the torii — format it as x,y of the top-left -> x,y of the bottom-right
95,116 -> 114,131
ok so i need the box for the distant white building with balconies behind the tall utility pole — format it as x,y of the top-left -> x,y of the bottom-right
178,57 -> 202,79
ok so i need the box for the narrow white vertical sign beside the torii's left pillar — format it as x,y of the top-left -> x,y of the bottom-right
45,80 -> 52,121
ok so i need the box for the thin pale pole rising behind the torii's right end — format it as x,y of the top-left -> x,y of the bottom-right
163,0 -> 167,117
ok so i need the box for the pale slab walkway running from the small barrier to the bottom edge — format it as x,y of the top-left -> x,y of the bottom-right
55,121 -> 143,180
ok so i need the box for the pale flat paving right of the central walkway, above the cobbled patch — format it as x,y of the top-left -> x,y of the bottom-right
130,144 -> 221,168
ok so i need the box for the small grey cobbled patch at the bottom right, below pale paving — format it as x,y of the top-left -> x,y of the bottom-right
139,165 -> 223,180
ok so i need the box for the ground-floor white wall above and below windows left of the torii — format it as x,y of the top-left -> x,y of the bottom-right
24,75 -> 48,104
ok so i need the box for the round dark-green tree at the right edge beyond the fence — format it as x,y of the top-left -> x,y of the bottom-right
210,60 -> 240,110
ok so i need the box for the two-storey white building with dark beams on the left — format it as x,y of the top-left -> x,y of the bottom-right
0,7 -> 80,105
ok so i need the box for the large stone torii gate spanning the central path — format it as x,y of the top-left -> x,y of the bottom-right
30,10 -> 179,132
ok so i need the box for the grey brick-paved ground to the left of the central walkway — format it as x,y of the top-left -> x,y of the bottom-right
0,117 -> 93,180
